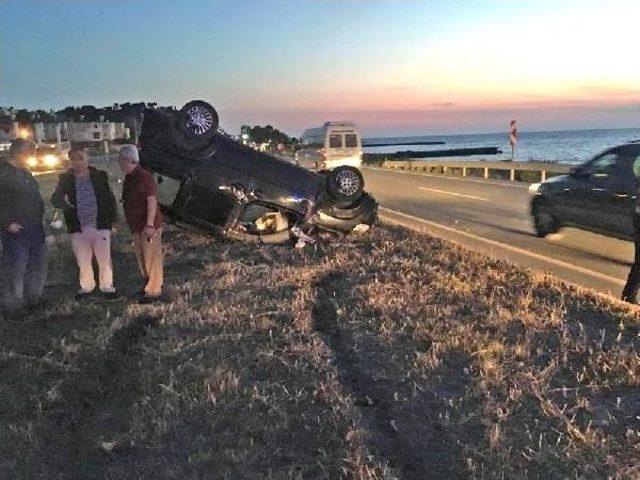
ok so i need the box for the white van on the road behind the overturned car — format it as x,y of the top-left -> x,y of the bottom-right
296,122 -> 362,170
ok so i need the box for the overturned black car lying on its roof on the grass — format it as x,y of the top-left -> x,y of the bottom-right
140,100 -> 378,243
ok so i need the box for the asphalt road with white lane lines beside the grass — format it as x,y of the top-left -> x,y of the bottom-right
363,168 -> 633,297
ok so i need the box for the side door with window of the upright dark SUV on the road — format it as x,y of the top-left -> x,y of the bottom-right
582,150 -> 636,235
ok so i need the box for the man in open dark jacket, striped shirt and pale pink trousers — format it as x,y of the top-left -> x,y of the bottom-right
51,147 -> 118,300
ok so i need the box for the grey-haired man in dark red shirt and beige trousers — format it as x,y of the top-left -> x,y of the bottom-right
118,145 -> 163,303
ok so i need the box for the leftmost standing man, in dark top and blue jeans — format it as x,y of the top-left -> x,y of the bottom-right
0,139 -> 47,318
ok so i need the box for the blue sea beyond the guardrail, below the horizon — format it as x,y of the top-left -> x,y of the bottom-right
363,128 -> 640,163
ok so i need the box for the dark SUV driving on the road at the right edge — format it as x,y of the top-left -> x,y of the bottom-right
530,143 -> 640,239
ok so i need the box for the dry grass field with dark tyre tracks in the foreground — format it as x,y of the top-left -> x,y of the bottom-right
0,167 -> 640,479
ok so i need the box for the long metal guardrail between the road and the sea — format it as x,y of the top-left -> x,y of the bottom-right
382,159 -> 571,182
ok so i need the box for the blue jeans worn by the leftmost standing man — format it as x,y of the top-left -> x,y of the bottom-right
0,225 -> 47,312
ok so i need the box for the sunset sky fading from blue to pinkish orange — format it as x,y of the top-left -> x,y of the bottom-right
0,0 -> 640,136
